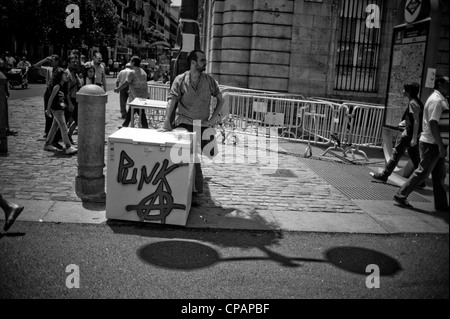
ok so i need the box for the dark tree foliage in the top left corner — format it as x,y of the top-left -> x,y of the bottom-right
0,0 -> 119,47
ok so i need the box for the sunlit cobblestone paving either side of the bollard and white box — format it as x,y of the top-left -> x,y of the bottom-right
0,91 -> 363,213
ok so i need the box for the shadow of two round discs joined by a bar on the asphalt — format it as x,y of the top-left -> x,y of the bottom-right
133,238 -> 402,277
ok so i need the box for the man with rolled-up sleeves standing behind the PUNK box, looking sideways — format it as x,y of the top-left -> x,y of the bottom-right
163,50 -> 223,206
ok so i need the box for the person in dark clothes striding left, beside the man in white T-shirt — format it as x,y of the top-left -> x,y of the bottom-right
371,82 -> 426,188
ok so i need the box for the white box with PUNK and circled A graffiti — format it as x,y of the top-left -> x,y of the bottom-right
106,127 -> 195,226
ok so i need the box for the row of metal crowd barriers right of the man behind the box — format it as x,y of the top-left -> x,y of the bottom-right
221,92 -> 384,151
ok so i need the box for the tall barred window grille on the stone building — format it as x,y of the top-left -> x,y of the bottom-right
334,0 -> 383,92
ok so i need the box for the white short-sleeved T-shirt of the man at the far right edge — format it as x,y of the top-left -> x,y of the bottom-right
420,90 -> 449,145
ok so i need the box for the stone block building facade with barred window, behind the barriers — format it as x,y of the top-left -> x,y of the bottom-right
202,0 -> 449,104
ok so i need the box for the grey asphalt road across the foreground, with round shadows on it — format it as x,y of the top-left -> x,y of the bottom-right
0,221 -> 449,300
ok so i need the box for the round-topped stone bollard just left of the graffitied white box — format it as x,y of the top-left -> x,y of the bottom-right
75,84 -> 108,203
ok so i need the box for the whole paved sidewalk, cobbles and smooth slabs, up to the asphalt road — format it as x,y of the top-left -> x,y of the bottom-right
0,91 -> 449,234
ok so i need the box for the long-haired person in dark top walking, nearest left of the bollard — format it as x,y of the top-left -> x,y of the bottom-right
44,68 -> 77,155
